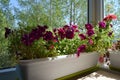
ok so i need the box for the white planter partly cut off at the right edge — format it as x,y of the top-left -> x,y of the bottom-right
110,51 -> 120,69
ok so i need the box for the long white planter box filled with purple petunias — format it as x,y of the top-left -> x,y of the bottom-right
20,52 -> 99,80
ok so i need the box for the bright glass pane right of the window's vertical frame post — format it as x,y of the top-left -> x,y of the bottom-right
104,0 -> 120,39
